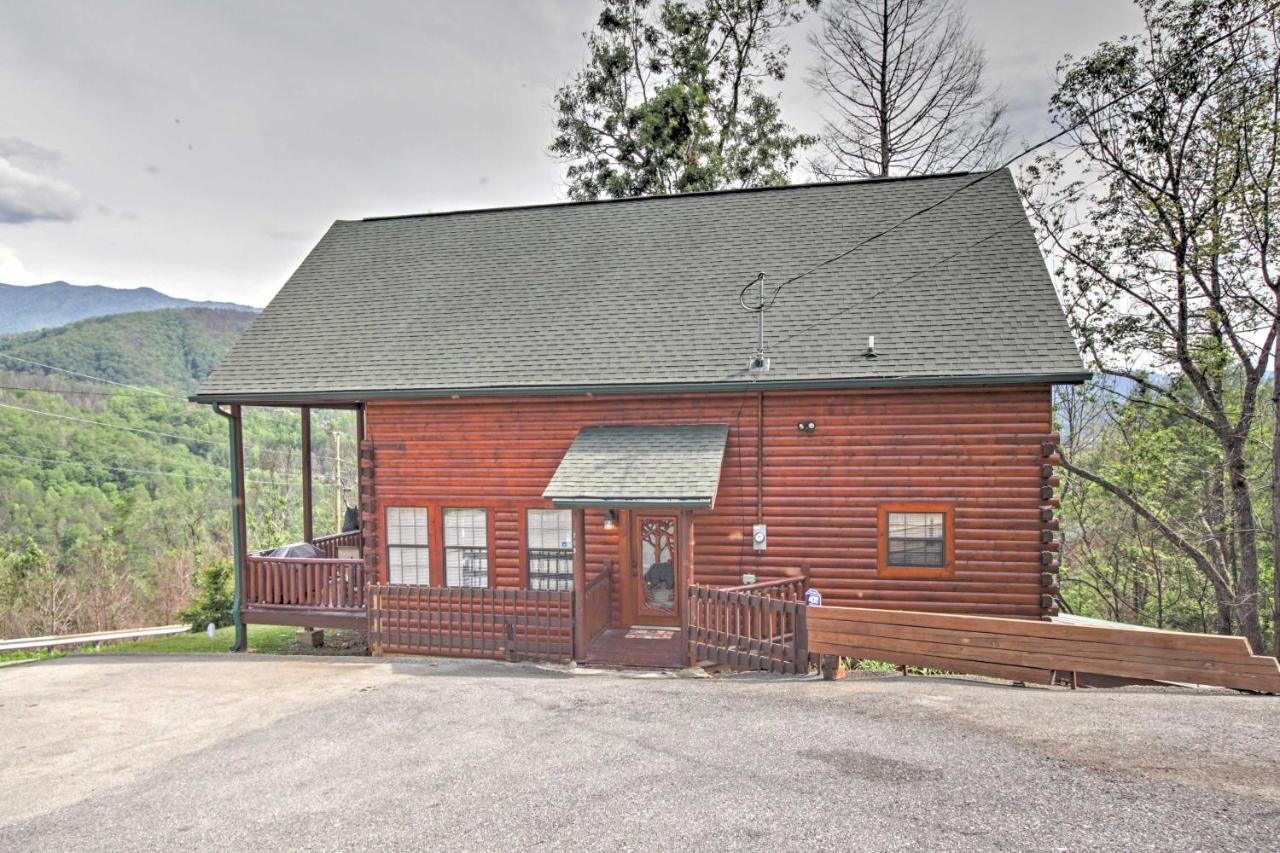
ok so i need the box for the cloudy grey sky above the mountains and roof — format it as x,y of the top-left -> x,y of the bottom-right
0,0 -> 1140,306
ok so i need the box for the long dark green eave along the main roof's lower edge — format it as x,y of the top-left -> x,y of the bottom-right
188,370 -> 1093,406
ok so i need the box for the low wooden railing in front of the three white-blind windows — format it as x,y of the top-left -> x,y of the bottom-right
369,584 -> 573,661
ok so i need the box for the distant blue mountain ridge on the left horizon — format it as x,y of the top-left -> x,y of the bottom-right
0,282 -> 257,334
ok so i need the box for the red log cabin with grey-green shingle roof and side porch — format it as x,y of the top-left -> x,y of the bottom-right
192,170 -> 1088,666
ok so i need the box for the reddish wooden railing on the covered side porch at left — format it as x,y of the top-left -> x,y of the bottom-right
241,556 -> 366,611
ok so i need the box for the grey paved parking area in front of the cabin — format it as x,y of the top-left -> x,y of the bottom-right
0,654 -> 1280,850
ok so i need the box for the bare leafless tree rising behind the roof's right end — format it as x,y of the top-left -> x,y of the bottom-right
809,0 -> 1009,179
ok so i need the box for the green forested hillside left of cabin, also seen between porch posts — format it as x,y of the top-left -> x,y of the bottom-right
0,309 -> 355,637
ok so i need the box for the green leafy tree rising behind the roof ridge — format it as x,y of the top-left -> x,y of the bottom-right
550,0 -> 818,200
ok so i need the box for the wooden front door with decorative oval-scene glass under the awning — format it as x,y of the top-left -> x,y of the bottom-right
623,512 -> 685,625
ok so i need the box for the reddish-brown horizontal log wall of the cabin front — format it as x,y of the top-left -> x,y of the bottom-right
366,386 -> 1056,619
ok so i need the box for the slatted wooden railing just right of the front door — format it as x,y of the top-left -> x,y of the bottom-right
685,578 -> 809,674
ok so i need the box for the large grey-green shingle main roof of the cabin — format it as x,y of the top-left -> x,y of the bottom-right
197,172 -> 1087,402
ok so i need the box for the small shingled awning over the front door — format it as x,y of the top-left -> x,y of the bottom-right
543,424 -> 728,508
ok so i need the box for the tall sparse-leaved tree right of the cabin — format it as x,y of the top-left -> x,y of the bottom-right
1028,0 -> 1280,649
